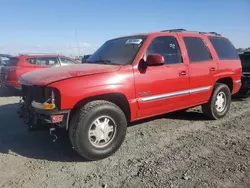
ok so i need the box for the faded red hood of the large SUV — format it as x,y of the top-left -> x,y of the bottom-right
19,64 -> 121,85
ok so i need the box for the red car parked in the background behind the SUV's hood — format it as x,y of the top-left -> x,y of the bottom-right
1,54 -> 79,89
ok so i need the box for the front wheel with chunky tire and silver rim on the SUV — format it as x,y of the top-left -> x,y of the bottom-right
69,100 -> 127,160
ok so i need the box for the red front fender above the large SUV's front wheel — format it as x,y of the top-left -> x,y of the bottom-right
49,71 -> 135,110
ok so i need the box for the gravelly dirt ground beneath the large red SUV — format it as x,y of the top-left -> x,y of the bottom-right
0,89 -> 250,188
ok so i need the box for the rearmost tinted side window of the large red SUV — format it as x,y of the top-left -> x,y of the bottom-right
208,37 -> 239,60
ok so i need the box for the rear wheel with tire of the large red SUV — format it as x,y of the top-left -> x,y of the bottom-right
202,83 -> 231,120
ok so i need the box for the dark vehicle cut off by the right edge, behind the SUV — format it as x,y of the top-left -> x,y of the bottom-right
239,51 -> 250,95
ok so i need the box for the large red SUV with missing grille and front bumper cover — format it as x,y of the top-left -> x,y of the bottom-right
20,29 -> 242,160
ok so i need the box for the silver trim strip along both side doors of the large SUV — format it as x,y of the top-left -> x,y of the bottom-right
141,86 -> 211,102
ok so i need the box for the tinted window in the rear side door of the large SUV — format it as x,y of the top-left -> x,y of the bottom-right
183,37 -> 212,63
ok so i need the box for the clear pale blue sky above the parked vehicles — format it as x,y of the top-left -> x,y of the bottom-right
0,0 -> 250,56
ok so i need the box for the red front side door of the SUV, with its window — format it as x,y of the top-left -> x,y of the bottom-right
134,34 -> 189,118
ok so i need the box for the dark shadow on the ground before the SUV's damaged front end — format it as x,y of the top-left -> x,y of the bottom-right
0,104 -> 86,162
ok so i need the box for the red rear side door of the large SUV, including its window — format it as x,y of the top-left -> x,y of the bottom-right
179,33 -> 218,105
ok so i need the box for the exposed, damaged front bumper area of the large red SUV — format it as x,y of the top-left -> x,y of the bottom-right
18,103 -> 70,130
